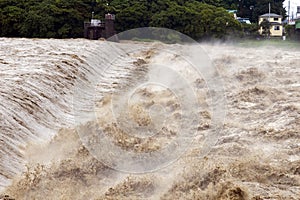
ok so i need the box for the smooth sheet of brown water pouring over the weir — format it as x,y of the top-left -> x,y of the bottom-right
0,38 -> 155,191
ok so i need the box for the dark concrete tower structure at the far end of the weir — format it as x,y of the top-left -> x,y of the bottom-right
84,13 -> 118,41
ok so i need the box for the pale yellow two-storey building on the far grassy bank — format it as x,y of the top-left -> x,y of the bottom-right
258,13 -> 283,37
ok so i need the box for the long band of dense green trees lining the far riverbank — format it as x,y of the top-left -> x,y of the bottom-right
0,0 -> 285,39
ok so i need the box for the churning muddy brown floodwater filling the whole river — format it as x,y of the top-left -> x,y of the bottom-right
0,38 -> 300,200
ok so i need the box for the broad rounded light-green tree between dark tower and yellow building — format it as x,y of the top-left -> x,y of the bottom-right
150,1 -> 241,39
